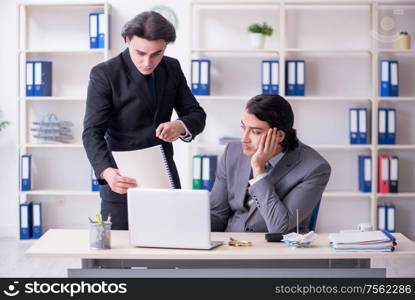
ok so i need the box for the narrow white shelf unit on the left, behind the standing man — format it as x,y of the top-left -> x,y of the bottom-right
18,2 -> 111,227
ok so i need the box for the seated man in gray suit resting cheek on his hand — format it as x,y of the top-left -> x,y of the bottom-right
210,94 -> 331,233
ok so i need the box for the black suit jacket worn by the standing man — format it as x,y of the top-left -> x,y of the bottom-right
82,49 -> 206,201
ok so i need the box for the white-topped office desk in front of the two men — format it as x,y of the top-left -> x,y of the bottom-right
26,229 -> 415,277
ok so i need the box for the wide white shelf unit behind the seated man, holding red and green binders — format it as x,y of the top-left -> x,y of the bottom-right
189,0 -> 415,236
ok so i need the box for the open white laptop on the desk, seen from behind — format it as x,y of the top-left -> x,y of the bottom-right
127,188 -> 223,249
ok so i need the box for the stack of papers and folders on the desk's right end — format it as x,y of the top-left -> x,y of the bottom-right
329,230 -> 396,252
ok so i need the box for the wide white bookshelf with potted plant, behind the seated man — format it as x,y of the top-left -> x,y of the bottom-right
189,0 -> 415,235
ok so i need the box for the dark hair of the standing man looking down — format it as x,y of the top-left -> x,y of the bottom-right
121,11 -> 176,44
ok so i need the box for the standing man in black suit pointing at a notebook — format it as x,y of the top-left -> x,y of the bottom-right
82,11 -> 206,229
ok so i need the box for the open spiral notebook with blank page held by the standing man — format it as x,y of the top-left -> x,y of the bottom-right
112,145 -> 174,189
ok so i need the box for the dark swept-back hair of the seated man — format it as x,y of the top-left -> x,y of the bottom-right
246,94 -> 298,151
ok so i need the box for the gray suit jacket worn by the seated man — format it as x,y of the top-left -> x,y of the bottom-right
210,142 -> 331,232
